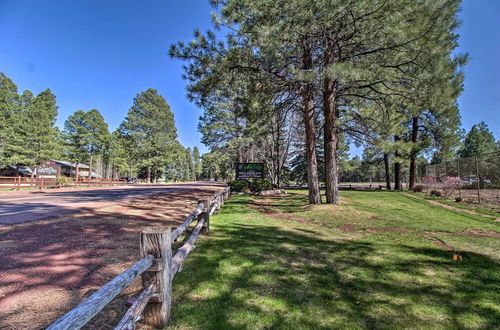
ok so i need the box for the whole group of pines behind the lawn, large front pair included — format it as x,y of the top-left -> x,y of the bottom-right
170,0 -> 467,204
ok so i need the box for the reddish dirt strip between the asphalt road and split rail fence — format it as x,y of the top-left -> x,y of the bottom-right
0,186 -> 223,329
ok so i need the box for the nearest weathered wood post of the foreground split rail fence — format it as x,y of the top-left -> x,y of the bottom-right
140,227 -> 173,328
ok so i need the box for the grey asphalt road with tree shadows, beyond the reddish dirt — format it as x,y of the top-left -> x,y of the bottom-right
0,183 -> 213,226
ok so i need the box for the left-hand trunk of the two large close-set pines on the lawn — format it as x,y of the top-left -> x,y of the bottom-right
301,43 -> 321,204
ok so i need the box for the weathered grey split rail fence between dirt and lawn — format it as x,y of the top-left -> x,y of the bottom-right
47,187 -> 231,330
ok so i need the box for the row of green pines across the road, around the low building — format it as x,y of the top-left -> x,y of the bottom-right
0,73 -> 202,182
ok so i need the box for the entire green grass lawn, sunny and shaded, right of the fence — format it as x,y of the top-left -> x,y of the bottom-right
169,191 -> 500,329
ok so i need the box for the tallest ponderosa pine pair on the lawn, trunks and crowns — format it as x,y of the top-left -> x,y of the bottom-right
171,0 -> 460,203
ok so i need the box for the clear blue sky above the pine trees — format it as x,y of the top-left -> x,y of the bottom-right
0,0 -> 500,154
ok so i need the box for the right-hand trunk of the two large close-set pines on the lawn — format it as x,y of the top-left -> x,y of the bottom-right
323,79 -> 340,204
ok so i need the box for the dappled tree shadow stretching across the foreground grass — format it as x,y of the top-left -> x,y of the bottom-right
171,218 -> 500,329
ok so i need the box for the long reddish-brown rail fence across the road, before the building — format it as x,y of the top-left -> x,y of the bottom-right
0,176 -> 127,190
